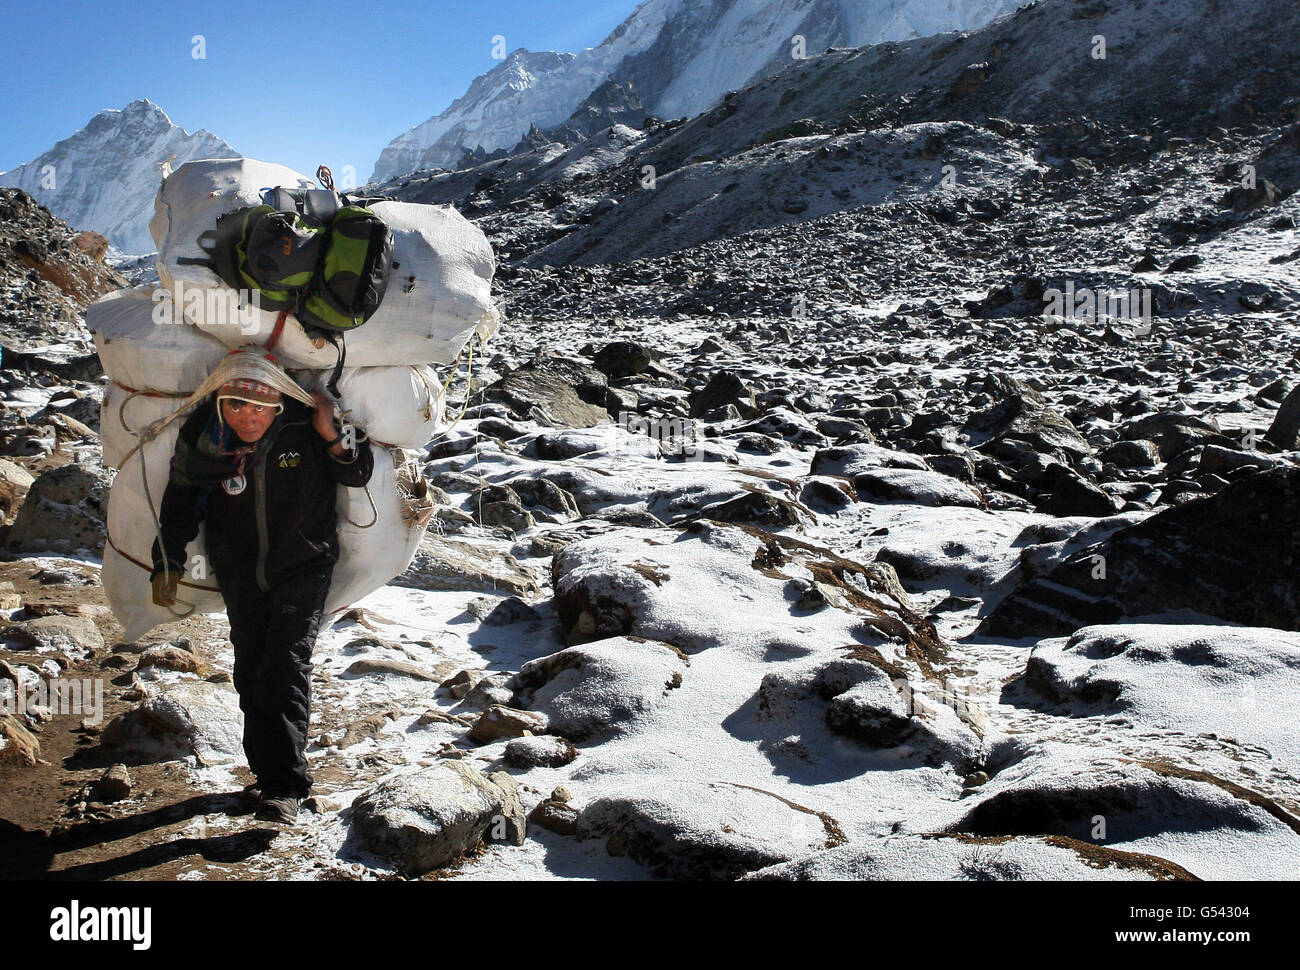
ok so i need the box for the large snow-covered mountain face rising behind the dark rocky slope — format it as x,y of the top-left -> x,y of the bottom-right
371,0 -> 1021,182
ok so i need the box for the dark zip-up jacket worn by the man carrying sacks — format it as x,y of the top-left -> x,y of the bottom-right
153,398 -> 374,592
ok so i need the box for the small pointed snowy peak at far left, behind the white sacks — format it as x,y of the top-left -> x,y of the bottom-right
0,99 -> 239,254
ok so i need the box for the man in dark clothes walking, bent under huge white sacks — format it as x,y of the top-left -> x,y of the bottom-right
151,352 -> 374,824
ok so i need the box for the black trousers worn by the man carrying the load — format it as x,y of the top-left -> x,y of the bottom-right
215,564 -> 334,798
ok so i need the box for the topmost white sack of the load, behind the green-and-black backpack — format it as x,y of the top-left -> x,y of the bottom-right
150,159 -> 499,369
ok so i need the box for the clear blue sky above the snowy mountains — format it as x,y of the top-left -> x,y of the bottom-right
0,0 -> 638,182
